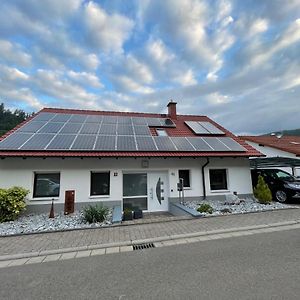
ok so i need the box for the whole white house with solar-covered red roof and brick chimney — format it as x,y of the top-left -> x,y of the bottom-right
0,102 -> 261,212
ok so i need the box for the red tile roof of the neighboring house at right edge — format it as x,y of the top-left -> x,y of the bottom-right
240,136 -> 300,156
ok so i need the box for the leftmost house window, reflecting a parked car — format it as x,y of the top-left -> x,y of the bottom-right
33,173 -> 60,198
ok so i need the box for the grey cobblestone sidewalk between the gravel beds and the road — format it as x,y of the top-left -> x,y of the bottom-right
0,209 -> 300,255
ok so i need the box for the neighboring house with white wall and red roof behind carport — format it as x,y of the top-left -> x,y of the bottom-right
240,135 -> 300,176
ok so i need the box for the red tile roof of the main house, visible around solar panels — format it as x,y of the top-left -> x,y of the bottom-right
0,108 -> 264,157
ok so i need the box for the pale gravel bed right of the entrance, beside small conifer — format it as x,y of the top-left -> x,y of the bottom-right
184,197 -> 295,216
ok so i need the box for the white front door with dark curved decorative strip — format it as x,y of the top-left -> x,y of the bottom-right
148,172 -> 169,211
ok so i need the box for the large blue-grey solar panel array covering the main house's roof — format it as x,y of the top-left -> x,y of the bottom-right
0,113 -> 246,152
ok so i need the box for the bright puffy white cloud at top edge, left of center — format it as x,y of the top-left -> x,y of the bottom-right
84,1 -> 134,52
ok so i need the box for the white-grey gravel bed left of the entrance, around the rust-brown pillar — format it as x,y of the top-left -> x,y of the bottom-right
0,210 -> 112,236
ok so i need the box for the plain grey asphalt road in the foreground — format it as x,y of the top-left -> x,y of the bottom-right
0,230 -> 300,300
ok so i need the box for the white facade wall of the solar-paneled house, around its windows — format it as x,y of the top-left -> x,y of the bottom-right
0,157 -> 252,210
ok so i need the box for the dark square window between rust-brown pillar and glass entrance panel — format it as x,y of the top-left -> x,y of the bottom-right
91,172 -> 110,196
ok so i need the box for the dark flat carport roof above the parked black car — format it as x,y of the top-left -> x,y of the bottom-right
250,157 -> 300,176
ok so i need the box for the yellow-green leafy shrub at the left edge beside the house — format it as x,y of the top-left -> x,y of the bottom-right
0,186 -> 29,223
